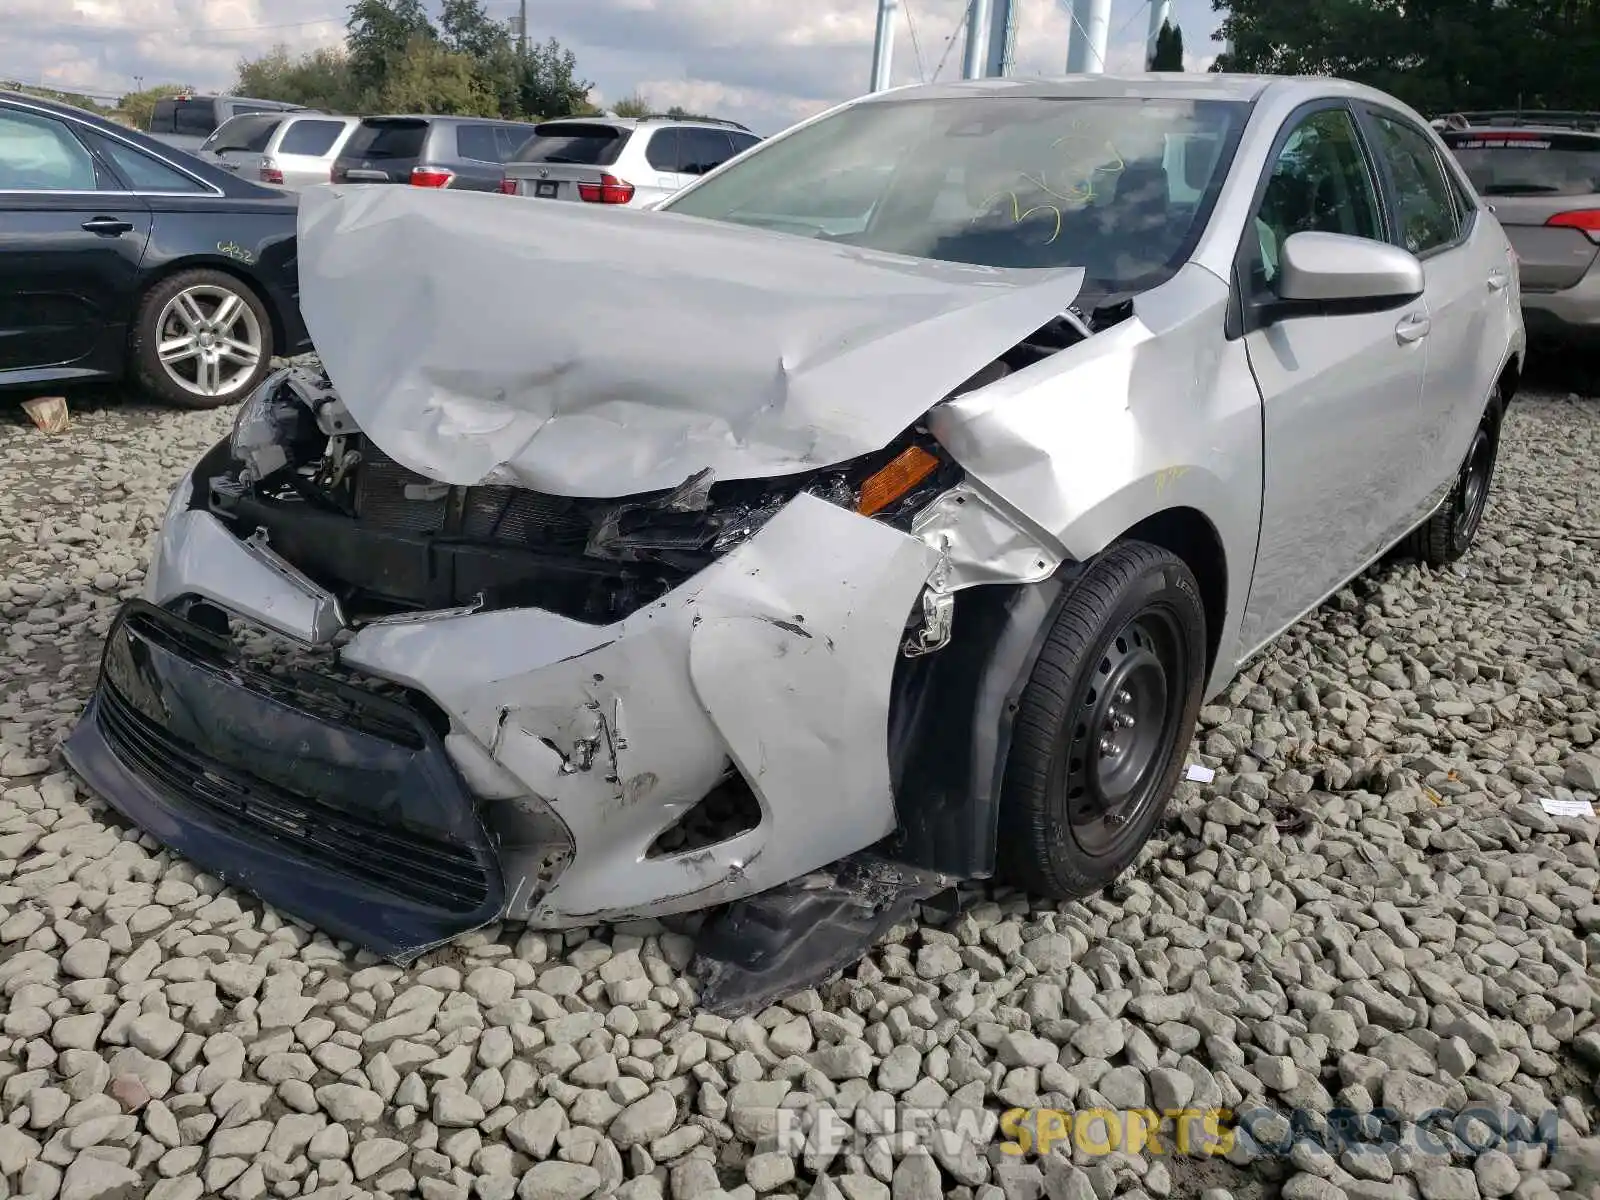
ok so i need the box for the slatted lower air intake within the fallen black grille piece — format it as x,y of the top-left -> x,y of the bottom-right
101,688 -> 488,912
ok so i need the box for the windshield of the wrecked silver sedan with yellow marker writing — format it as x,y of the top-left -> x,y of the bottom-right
662,96 -> 1248,290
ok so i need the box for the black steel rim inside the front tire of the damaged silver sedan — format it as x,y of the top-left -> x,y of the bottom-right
1051,610 -> 1186,858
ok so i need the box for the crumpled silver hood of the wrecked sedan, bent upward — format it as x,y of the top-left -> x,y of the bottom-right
299,186 -> 1083,498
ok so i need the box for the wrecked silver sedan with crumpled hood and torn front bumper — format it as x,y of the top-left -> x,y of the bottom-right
67,74 -> 1523,1013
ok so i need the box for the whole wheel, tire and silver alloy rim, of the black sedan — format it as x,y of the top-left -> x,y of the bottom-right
130,269 -> 272,408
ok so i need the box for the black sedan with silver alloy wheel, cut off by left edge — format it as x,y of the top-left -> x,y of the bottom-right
0,93 -> 309,408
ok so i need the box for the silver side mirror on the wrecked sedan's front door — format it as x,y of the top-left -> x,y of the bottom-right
1269,232 -> 1426,320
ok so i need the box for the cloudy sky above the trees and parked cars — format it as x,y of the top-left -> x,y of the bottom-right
0,0 -> 1219,133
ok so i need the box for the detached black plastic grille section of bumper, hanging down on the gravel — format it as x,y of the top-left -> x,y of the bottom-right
64,600 -> 506,962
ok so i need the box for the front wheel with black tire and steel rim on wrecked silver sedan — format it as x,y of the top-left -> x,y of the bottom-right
998,542 -> 1206,899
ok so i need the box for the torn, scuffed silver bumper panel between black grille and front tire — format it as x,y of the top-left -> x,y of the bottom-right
344,494 -> 936,926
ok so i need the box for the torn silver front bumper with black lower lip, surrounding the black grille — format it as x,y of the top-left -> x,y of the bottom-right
103,488 -> 941,934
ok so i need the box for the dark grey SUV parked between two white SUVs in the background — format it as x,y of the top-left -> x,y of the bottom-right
331,117 -> 534,192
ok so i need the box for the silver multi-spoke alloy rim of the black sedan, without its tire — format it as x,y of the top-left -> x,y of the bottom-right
155,283 -> 266,398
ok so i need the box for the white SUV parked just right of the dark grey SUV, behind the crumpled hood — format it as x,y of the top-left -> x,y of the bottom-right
501,117 -> 760,208
